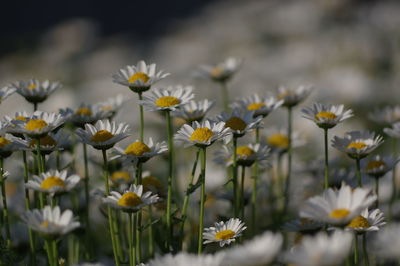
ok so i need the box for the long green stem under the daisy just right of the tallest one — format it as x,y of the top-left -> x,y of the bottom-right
165,111 -> 174,250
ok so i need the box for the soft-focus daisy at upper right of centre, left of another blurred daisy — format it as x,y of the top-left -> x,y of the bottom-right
232,94 -> 283,117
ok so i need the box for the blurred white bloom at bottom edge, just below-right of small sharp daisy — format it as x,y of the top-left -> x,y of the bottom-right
221,232 -> 283,266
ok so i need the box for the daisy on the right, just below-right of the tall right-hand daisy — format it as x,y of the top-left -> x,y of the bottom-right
332,131 -> 383,159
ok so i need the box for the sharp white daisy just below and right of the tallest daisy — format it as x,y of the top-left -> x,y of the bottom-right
139,85 -> 194,111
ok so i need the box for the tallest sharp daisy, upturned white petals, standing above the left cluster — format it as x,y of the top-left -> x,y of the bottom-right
112,61 -> 169,93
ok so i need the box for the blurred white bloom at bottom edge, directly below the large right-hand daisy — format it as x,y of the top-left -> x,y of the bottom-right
284,231 -> 353,266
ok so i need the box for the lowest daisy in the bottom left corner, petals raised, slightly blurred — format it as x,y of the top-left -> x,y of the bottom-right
21,206 -> 80,237
